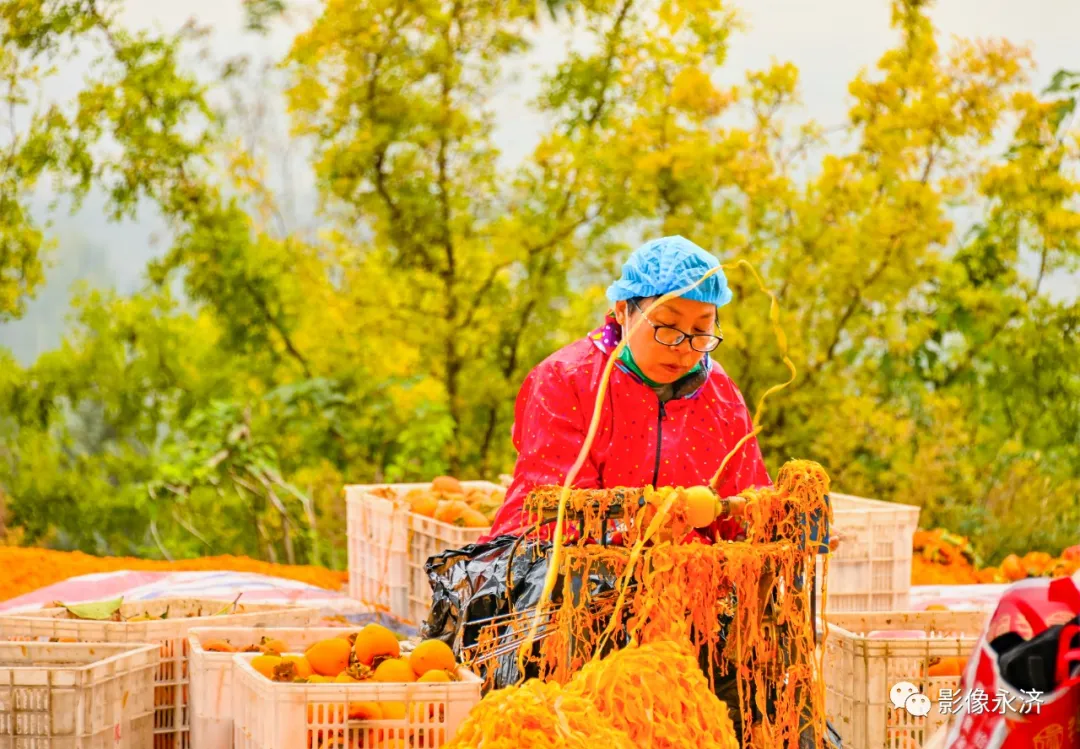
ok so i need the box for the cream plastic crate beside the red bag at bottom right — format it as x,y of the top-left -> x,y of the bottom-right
824,611 -> 989,749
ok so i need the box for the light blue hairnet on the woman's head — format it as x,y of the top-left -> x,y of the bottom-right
607,235 -> 732,307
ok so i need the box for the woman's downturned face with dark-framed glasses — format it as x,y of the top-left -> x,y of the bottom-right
615,297 -> 716,384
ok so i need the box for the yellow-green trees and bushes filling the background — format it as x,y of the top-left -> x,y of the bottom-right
0,0 -> 1080,563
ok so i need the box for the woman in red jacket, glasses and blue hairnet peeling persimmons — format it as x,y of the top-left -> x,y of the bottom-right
487,236 -> 771,540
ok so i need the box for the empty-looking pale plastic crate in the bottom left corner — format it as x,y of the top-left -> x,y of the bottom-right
0,642 -> 158,749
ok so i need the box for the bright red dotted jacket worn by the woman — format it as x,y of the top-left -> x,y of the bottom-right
485,319 -> 772,540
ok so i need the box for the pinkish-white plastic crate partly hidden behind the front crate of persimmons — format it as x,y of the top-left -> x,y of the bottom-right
188,625 -> 360,749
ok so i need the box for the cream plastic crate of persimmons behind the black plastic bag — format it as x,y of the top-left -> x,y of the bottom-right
346,481 -> 503,624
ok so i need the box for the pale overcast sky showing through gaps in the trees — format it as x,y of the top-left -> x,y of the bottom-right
0,0 -> 1080,358
